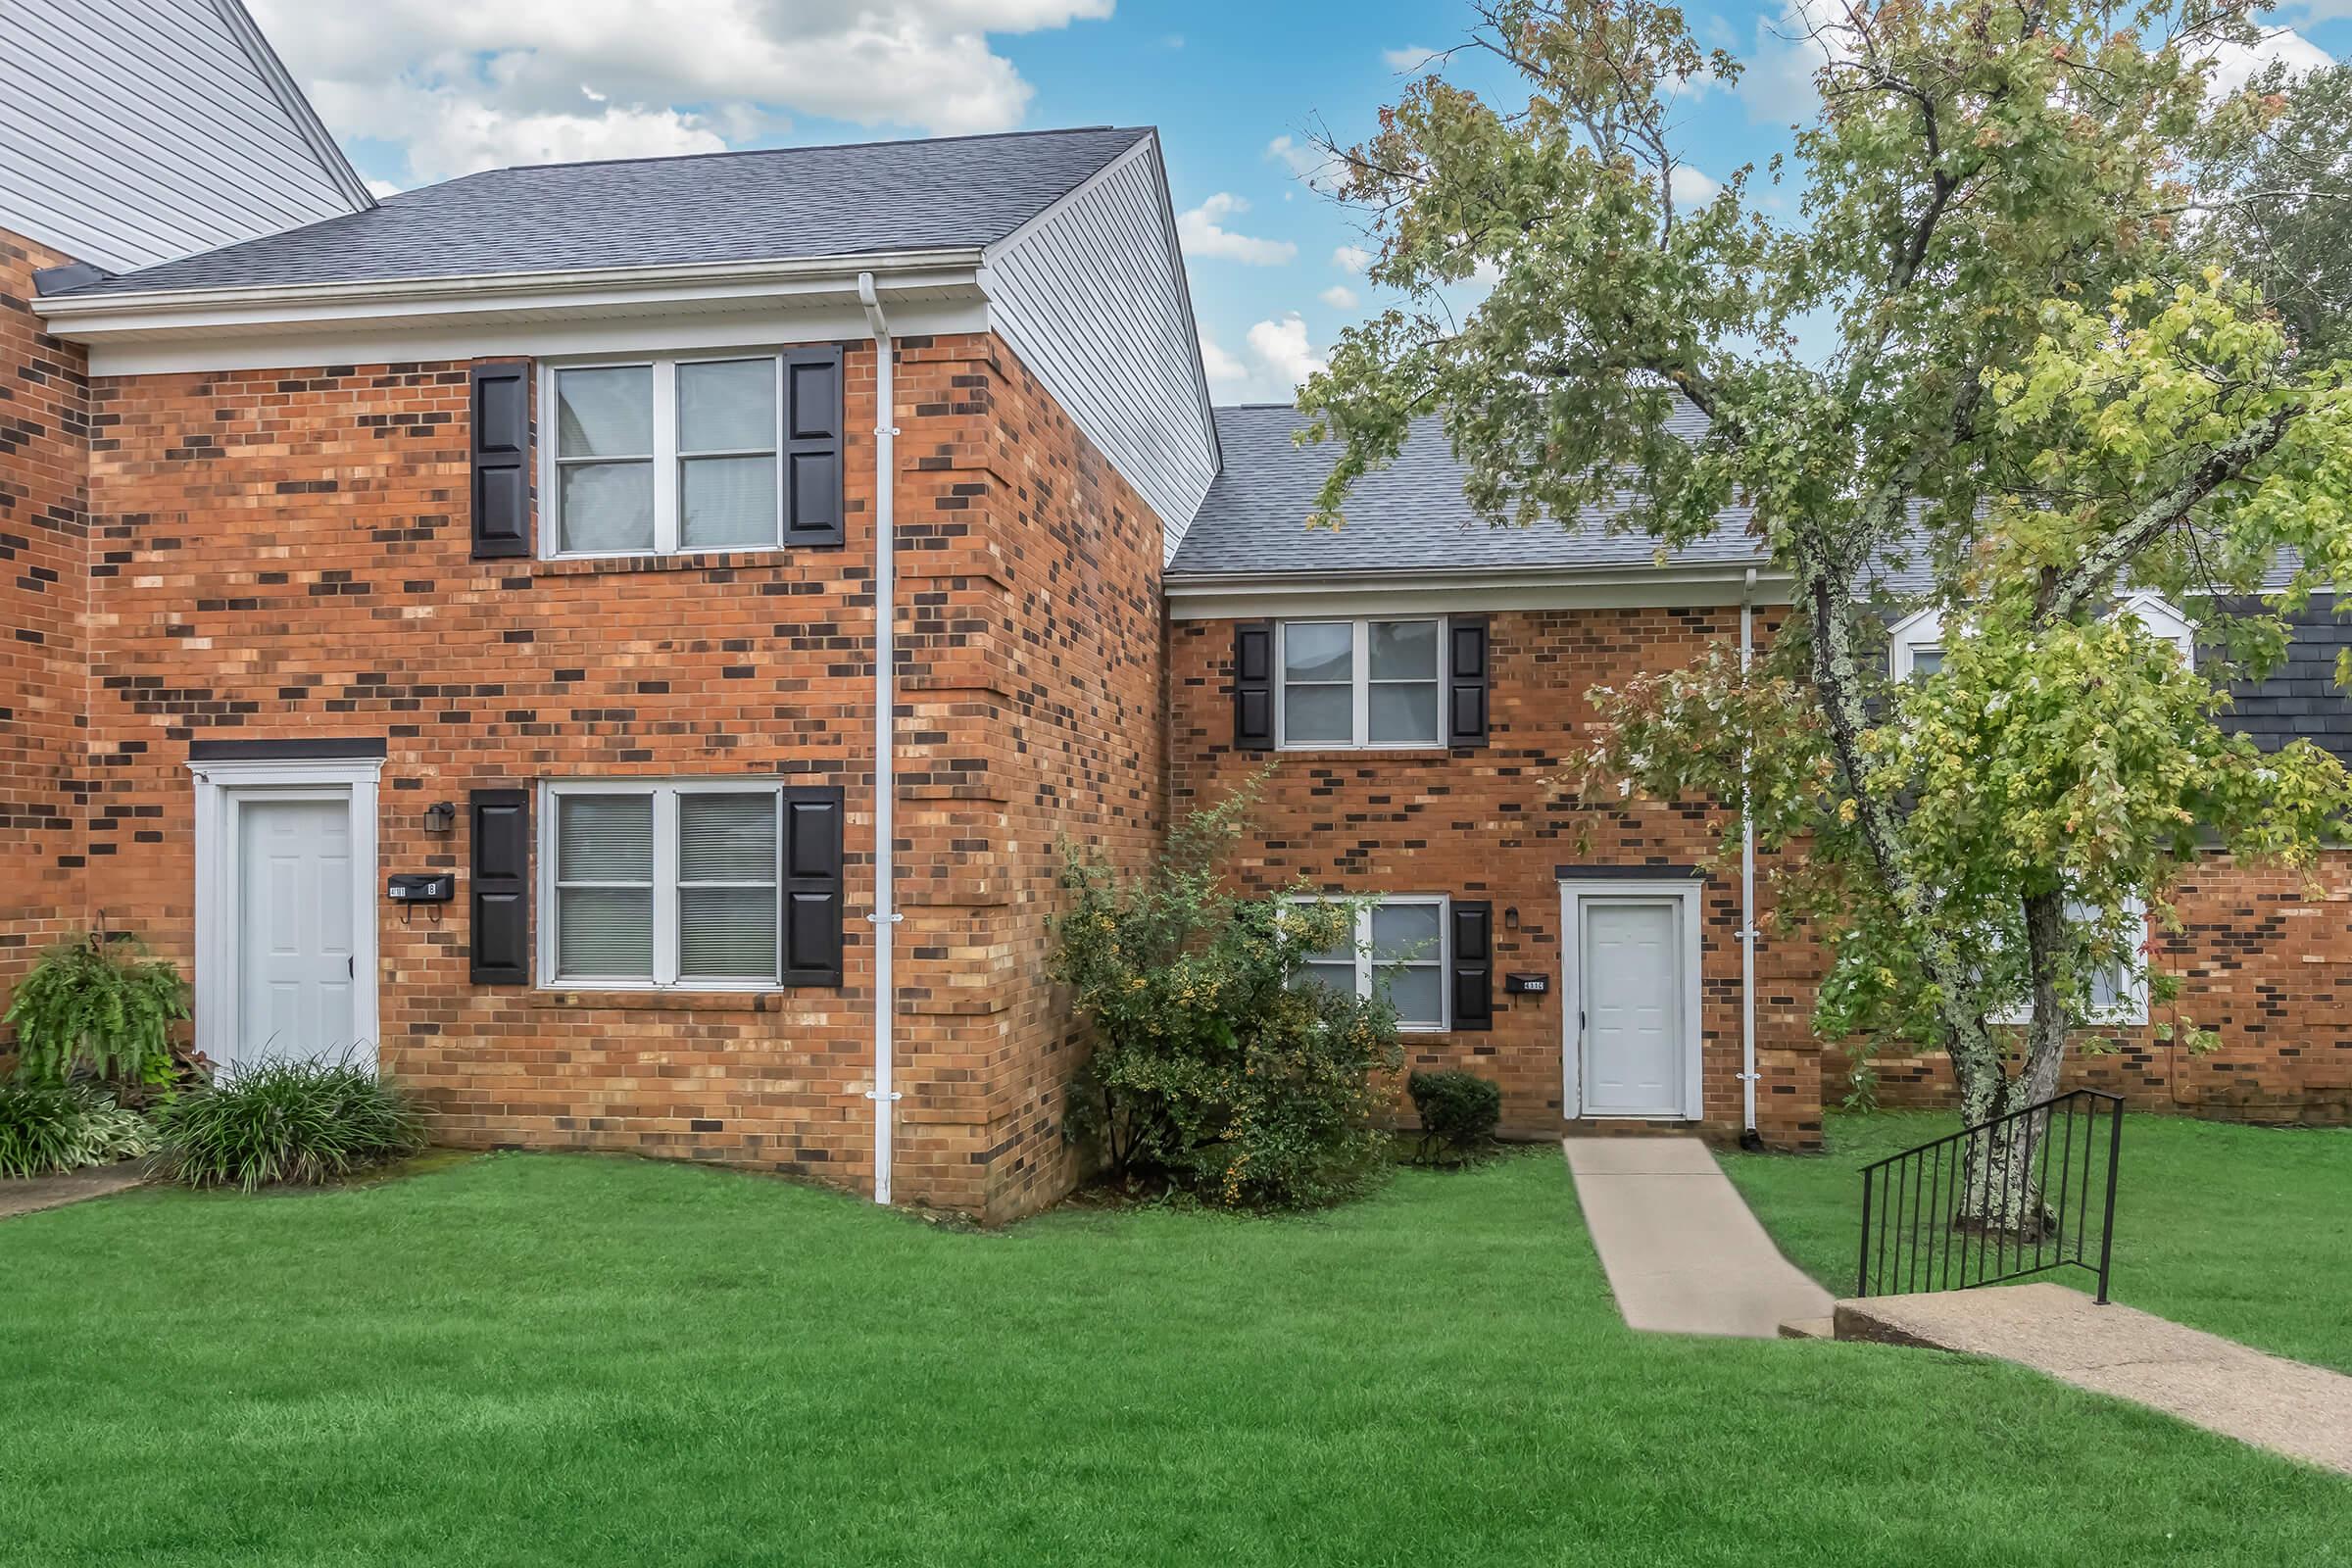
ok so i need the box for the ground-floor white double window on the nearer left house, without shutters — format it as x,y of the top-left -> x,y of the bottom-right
541,783 -> 783,990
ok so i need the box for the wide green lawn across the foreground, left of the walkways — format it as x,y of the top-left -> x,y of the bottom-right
0,1152 -> 2352,1568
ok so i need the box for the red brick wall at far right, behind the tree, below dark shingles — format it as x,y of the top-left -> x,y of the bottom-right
1830,851 -> 2352,1126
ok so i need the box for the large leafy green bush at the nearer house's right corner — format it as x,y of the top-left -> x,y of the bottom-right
1052,776 -> 1401,1208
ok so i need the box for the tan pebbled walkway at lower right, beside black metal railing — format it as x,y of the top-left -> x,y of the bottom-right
1837,1281 -> 2352,1474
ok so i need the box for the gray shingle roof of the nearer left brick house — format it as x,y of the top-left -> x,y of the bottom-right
48,127 -> 1151,296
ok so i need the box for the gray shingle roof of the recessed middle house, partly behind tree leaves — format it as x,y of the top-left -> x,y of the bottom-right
1169,405 -> 1762,576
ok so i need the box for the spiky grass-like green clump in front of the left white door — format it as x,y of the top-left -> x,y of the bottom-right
155,1062 -> 425,1192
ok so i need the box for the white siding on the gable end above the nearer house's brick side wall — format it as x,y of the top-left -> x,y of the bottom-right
988,141 -> 1216,555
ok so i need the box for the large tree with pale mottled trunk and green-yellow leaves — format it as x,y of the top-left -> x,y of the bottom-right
1300,0 -> 2352,1225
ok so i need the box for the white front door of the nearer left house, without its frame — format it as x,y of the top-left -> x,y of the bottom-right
228,797 -> 367,1065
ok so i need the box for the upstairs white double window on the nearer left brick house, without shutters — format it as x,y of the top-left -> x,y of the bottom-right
546,355 -> 786,555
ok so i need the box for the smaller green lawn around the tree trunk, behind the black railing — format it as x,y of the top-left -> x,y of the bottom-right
1719,1112 -> 2352,1373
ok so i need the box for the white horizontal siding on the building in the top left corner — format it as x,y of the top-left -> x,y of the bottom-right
0,0 -> 353,270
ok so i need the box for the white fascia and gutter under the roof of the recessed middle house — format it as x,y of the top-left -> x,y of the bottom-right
1164,562 -> 1789,620
